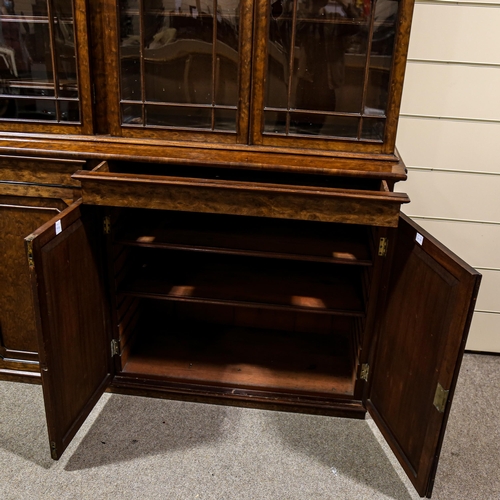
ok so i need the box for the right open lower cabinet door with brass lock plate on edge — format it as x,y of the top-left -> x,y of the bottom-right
365,216 -> 481,497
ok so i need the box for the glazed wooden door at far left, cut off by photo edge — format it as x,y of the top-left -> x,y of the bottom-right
0,0 -> 93,134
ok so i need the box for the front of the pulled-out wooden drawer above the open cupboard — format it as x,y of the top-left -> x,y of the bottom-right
73,162 -> 409,227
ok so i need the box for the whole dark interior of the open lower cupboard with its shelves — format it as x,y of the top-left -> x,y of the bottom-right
110,209 -> 373,397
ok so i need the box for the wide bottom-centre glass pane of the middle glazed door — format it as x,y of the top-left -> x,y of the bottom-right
146,104 -> 212,129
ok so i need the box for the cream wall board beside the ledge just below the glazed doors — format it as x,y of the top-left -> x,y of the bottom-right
397,116 -> 500,173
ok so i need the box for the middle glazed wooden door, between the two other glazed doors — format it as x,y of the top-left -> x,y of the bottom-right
102,0 -> 253,144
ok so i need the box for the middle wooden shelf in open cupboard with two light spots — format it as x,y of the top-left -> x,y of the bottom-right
120,249 -> 365,316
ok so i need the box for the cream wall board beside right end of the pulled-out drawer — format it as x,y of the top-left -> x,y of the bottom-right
395,169 -> 500,224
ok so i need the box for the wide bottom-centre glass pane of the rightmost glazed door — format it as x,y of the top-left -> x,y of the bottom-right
290,113 -> 359,138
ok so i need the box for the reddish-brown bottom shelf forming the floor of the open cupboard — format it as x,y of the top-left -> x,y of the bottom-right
122,318 -> 354,396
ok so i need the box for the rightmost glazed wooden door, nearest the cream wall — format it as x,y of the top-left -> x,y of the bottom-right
252,0 -> 413,153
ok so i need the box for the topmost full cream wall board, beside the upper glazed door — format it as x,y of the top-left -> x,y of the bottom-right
408,2 -> 500,64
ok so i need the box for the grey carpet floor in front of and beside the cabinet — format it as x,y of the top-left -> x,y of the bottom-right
0,354 -> 500,500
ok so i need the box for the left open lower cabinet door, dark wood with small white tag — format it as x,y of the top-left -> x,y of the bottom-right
26,202 -> 111,460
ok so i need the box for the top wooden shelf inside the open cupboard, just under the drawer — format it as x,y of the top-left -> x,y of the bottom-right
115,210 -> 372,266
